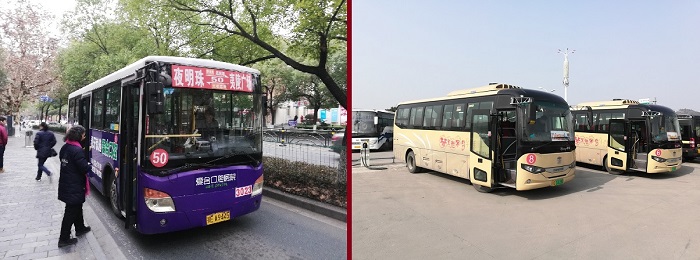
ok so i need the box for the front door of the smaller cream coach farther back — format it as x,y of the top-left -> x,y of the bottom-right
606,119 -> 633,172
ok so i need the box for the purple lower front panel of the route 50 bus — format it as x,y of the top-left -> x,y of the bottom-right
135,166 -> 263,234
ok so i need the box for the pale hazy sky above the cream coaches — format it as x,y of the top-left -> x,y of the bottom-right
351,0 -> 700,111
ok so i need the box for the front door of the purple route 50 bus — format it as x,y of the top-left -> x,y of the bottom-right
115,82 -> 140,229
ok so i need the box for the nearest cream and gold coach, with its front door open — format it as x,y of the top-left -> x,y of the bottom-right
394,83 -> 576,192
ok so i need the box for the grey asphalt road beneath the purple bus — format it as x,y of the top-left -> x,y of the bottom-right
88,190 -> 347,259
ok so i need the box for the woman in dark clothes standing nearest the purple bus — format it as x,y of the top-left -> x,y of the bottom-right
58,125 -> 90,247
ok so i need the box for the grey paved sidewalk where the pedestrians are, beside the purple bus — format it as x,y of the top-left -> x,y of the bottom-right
0,130 -> 126,259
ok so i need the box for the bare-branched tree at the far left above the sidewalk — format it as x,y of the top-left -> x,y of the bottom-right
0,1 -> 58,115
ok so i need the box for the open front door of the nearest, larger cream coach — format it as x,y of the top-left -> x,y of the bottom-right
469,109 -> 496,192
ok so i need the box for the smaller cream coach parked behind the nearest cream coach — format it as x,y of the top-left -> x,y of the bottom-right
572,99 -> 683,174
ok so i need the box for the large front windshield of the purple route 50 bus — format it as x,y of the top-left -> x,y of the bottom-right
144,87 -> 262,172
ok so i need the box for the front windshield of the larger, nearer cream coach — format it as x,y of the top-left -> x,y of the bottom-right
523,101 -> 574,142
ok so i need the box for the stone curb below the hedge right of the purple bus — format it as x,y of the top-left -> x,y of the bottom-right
263,187 -> 348,222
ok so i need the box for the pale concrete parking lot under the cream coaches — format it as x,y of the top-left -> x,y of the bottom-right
352,158 -> 700,259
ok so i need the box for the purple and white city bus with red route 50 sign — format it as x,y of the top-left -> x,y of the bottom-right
68,56 -> 266,234
